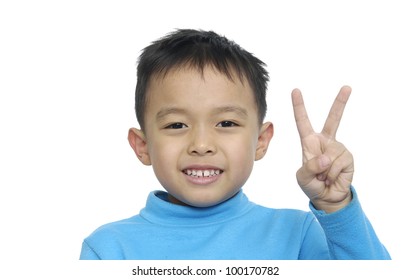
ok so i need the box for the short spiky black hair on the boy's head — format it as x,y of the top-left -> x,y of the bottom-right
135,29 -> 269,130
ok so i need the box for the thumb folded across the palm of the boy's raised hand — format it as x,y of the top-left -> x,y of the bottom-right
296,155 -> 331,186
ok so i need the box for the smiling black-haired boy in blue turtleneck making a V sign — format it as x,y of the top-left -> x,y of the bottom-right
80,30 -> 390,259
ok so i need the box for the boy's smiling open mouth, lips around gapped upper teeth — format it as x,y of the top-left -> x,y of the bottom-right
181,165 -> 224,186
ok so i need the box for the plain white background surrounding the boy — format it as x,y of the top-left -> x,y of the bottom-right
0,0 -> 410,278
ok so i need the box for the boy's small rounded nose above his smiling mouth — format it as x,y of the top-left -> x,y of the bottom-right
188,127 -> 216,156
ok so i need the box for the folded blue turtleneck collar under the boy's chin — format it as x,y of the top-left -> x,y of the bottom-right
140,190 -> 254,226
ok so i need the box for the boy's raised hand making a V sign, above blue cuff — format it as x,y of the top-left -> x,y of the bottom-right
292,86 -> 354,213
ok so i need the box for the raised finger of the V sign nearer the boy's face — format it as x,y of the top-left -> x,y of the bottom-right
292,88 -> 314,139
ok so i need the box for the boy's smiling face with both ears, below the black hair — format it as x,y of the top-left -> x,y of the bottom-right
129,67 -> 273,207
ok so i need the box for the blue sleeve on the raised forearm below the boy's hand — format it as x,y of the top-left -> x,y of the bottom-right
309,187 -> 391,260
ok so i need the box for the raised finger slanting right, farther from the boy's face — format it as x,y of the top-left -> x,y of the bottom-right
322,86 -> 352,138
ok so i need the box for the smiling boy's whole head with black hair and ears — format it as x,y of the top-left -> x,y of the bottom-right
128,30 -> 273,207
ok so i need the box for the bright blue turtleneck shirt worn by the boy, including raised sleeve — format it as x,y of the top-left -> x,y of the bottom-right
80,188 -> 390,260
